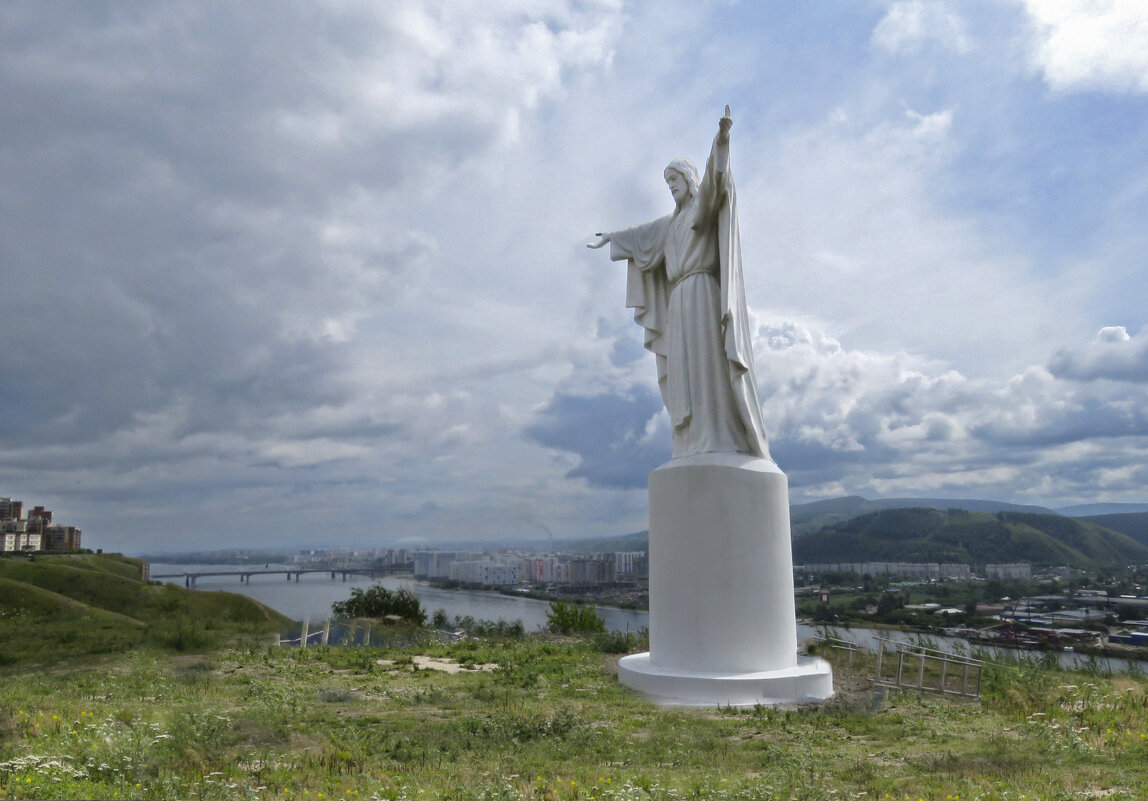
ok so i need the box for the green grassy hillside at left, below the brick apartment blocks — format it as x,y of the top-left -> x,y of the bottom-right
0,554 -> 288,663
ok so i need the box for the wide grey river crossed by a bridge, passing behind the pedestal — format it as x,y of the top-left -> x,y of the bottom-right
152,562 -> 1148,672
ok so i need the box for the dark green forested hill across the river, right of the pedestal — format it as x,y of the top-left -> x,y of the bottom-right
793,508 -> 1148,569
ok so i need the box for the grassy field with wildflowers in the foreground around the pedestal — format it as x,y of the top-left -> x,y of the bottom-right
0,636 -> 1148,801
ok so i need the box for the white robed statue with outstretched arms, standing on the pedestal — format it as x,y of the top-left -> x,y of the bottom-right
587,106 -> 769,459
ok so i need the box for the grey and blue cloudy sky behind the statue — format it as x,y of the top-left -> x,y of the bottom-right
0,0 -> 1148,552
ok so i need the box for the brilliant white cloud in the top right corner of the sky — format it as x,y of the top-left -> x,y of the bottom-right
1022,0 -> 1148,93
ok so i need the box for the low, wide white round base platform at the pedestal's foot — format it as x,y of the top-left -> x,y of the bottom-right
618,652 -> 833,707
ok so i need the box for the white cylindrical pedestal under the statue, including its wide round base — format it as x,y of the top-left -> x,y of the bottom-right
619,453 -> 832,705
